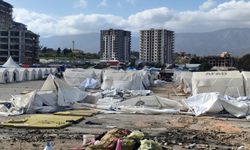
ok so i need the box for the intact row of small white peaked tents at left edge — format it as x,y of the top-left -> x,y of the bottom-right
0,57 -> 57,83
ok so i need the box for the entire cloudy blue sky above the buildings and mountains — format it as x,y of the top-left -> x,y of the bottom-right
5,0 -> 250,37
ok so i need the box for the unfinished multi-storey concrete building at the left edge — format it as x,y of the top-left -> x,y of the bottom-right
0,0 -> 39,64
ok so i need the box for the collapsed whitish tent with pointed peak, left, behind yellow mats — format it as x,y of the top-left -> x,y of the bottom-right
0,75 -> 87,116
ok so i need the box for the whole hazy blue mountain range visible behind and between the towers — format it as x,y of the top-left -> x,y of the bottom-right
40,28 -> 250,55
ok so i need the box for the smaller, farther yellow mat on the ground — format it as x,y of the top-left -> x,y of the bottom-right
54,109 -> 98,117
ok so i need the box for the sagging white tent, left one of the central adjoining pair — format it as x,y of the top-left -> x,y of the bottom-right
63,68 -> 102,87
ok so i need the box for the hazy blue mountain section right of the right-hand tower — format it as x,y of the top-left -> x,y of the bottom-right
175,29 -> 250,55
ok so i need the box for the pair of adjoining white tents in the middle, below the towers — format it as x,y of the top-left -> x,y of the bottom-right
63,69 -> 152,90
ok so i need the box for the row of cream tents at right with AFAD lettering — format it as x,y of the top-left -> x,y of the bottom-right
174,71 -> 250,97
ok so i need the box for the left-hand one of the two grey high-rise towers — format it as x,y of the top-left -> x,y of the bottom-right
100,29 -> 131,62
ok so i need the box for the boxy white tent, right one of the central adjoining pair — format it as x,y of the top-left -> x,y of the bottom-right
101,70 -> 145,90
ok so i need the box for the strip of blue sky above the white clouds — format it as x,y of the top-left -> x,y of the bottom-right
6,0 -> 226,17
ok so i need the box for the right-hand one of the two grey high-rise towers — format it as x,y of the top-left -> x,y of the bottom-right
140,29 -> 174,64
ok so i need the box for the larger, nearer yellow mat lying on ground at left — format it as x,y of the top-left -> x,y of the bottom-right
1,114 -> 84,129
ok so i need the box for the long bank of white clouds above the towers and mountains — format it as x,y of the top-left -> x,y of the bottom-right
14,0 -> 250,36
